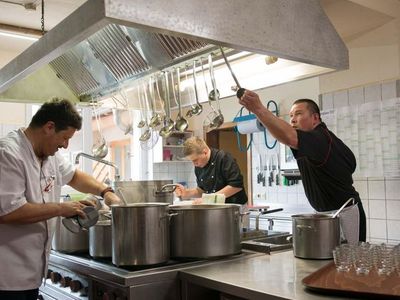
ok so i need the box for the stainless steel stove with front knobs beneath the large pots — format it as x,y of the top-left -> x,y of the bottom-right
40,251 -> 261,300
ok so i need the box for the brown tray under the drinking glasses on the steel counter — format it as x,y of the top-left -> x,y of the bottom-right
302,262 -> 400,299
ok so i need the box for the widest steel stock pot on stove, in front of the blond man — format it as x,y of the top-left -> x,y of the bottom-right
170,204 -> 241,258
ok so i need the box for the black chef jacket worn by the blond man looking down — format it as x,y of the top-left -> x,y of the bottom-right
194,148 -> 247,204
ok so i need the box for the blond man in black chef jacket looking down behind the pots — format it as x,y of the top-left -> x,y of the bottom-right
175,137 -> 247,204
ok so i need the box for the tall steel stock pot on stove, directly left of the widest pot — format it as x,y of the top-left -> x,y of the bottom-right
111,203 -> 170,266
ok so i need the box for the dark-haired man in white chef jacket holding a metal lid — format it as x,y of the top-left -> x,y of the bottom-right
0,99 -> 120,300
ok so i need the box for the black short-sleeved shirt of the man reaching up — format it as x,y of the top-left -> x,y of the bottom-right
292,123 -> 360,211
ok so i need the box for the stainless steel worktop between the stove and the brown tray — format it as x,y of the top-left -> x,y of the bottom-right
180,251 -> 353,300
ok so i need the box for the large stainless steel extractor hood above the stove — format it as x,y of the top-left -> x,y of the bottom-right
0,0 -> 348,102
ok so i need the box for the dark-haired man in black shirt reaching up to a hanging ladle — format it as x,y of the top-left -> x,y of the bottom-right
239,90 -> 366,243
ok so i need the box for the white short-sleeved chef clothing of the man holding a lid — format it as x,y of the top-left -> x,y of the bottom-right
0,128 -> 75,290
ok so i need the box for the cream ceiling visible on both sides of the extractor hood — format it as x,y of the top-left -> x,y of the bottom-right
0,0 -> 400,67
